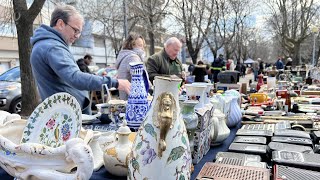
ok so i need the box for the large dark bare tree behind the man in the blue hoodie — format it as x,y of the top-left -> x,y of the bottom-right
2,0 -> 45,115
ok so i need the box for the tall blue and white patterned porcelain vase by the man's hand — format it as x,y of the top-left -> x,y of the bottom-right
126,62 -> 149,130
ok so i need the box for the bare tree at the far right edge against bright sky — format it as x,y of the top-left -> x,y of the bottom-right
266,0 -> 320,64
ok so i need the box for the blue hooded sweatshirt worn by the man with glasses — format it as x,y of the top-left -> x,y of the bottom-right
30,25 -> 118,110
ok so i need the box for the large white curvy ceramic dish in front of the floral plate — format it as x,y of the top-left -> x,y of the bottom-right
0,120 -> 94,180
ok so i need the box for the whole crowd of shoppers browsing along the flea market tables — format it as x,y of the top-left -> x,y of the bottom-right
30,5 -> 298,114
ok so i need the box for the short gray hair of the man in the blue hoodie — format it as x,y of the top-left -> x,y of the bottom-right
50,4 -> 84,27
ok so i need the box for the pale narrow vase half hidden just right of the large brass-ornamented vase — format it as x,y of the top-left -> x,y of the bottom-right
181,100 -> 199,153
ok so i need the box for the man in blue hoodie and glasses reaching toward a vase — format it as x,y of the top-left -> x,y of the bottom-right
30,5 -> 130,114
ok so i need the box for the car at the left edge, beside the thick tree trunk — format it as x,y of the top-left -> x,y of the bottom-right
0,67 -> 21,113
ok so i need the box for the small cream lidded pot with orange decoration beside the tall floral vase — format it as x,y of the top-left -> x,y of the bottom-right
103,120 -> 132,176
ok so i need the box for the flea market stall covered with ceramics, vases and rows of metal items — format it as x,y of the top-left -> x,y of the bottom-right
0,64 -> 320,180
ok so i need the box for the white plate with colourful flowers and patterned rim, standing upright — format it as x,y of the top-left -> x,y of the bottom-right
21,93 -> 82,147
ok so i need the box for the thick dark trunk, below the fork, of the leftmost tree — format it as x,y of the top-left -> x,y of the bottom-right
17,22 -> 39,116
